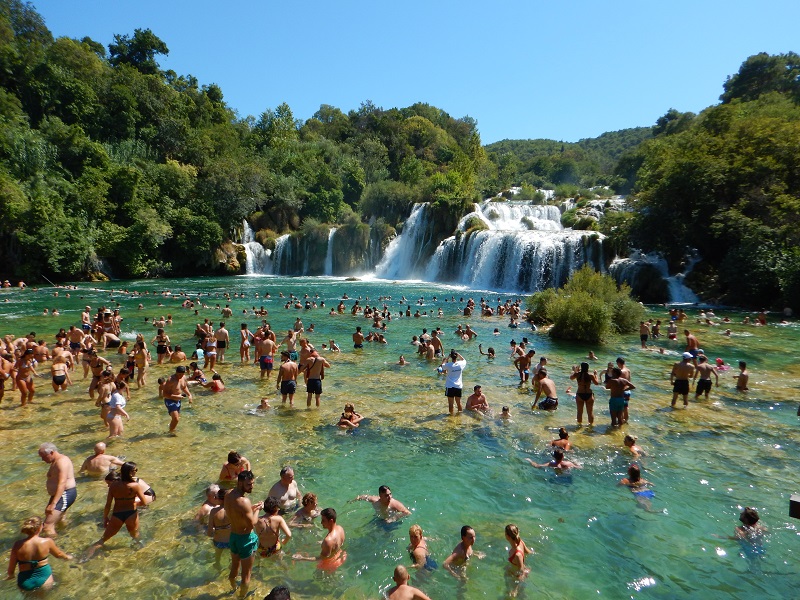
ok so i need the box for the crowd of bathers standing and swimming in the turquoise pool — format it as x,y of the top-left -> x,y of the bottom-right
0,284 -> 780,599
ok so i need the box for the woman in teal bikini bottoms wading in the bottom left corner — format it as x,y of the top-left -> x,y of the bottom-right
8,517 -> 72,592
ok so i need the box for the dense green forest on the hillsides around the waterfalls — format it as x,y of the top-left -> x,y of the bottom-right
0,0 -> 800,305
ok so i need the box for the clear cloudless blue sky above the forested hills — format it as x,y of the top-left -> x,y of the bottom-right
33,0 -> 800,143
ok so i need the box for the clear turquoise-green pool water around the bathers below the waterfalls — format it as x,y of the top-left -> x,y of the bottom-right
0,277 -> 800,598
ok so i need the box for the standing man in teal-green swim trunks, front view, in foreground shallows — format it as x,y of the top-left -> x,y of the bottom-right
223,471 -> 264,598
